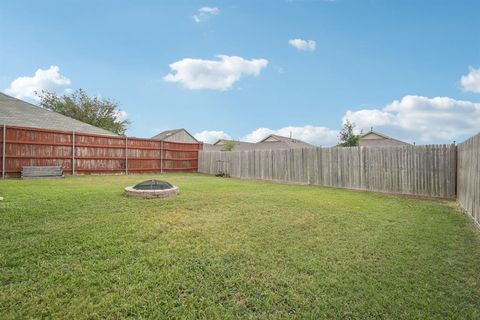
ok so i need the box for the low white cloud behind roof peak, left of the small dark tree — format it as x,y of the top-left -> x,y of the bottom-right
242,125 -> 338,146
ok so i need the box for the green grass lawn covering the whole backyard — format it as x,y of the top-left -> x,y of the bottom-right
0,174 -> 480,319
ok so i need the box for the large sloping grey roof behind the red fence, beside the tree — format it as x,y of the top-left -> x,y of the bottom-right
0,92 -> 117,136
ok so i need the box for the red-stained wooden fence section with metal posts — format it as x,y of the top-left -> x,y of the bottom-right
0,126 -> 202,177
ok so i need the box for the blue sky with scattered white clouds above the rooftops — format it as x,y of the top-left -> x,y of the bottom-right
0,0 -> 480,145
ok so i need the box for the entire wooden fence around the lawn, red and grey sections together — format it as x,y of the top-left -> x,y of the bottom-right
0,126 -> 480,228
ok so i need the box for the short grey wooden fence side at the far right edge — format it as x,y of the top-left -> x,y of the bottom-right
457,134 -> 480,228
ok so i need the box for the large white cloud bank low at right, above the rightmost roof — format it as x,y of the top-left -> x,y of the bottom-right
343,96 -> 480,143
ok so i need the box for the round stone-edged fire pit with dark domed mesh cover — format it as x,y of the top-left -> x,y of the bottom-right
125,179 -> 180,198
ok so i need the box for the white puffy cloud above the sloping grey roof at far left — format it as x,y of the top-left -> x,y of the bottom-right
5,66 -> 71,99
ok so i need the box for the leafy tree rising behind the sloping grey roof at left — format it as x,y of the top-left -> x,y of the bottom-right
36,89 -> 130,135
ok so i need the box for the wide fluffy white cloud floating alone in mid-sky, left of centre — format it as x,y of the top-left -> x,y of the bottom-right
163,55 -> 268,90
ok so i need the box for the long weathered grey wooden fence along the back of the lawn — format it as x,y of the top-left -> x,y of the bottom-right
199,145 -> 456,198
